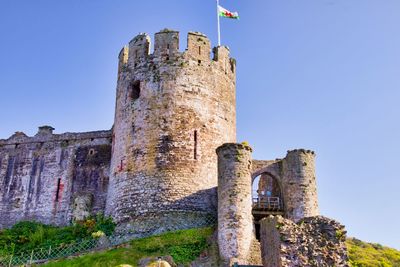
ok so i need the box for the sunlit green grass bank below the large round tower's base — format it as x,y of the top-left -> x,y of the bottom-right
41,228 -> 214,267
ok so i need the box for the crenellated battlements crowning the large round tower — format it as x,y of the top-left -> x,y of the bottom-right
118,29 -> 236,80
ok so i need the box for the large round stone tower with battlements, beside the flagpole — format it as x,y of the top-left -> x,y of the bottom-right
106,30 -> 236,232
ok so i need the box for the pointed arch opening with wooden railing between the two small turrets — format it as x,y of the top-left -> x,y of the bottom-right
252,173 -> 285,240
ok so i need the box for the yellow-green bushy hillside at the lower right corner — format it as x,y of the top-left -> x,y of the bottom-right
347,238 -> 400,267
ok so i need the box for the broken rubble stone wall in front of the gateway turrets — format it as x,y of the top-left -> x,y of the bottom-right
261,216 -> 349,267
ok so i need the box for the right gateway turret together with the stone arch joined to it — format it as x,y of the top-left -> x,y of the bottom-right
252,149 -> 319,221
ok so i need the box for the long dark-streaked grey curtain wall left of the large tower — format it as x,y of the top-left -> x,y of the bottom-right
0,126 -> 111,228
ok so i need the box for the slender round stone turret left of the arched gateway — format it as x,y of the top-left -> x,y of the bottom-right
217,144 -> 255,266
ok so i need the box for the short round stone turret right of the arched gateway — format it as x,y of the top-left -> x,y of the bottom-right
282,149 -> 319,221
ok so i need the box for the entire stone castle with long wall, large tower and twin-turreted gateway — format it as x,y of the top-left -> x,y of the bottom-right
0,30 -> 346,262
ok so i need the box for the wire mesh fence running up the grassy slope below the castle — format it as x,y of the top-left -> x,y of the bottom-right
0,214 -> 217,267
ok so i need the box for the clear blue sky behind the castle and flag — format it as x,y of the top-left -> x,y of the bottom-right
0,0 -> 400,249
